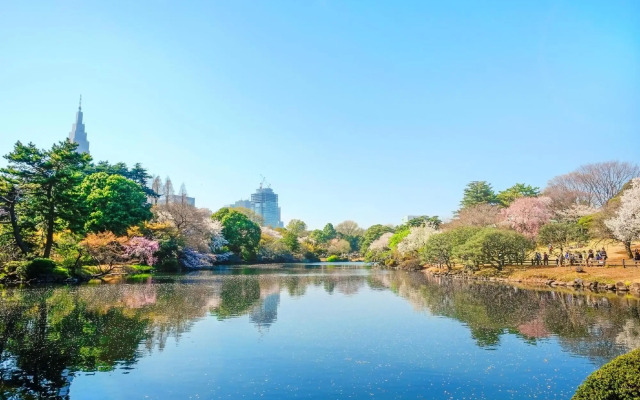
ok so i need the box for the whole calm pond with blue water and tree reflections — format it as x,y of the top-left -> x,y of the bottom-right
0,264 -> 640,399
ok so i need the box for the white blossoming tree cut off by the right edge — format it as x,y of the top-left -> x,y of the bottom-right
604,178 -> 640,257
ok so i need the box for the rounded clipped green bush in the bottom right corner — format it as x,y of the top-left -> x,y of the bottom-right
572,349 -> 640,400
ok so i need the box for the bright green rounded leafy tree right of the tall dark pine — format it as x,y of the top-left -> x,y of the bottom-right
79,172 -> 152,236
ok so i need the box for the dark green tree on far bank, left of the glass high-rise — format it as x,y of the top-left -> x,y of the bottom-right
211,207 -> 260,261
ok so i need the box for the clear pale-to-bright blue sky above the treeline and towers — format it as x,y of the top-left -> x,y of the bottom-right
0,0 -> 640,227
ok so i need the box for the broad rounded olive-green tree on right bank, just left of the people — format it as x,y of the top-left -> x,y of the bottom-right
455,228 -> 534,270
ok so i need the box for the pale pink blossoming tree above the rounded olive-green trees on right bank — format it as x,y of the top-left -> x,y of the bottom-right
502,197 -> 553,239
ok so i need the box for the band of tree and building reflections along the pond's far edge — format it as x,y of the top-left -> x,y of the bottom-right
0,268 -> 640,398
